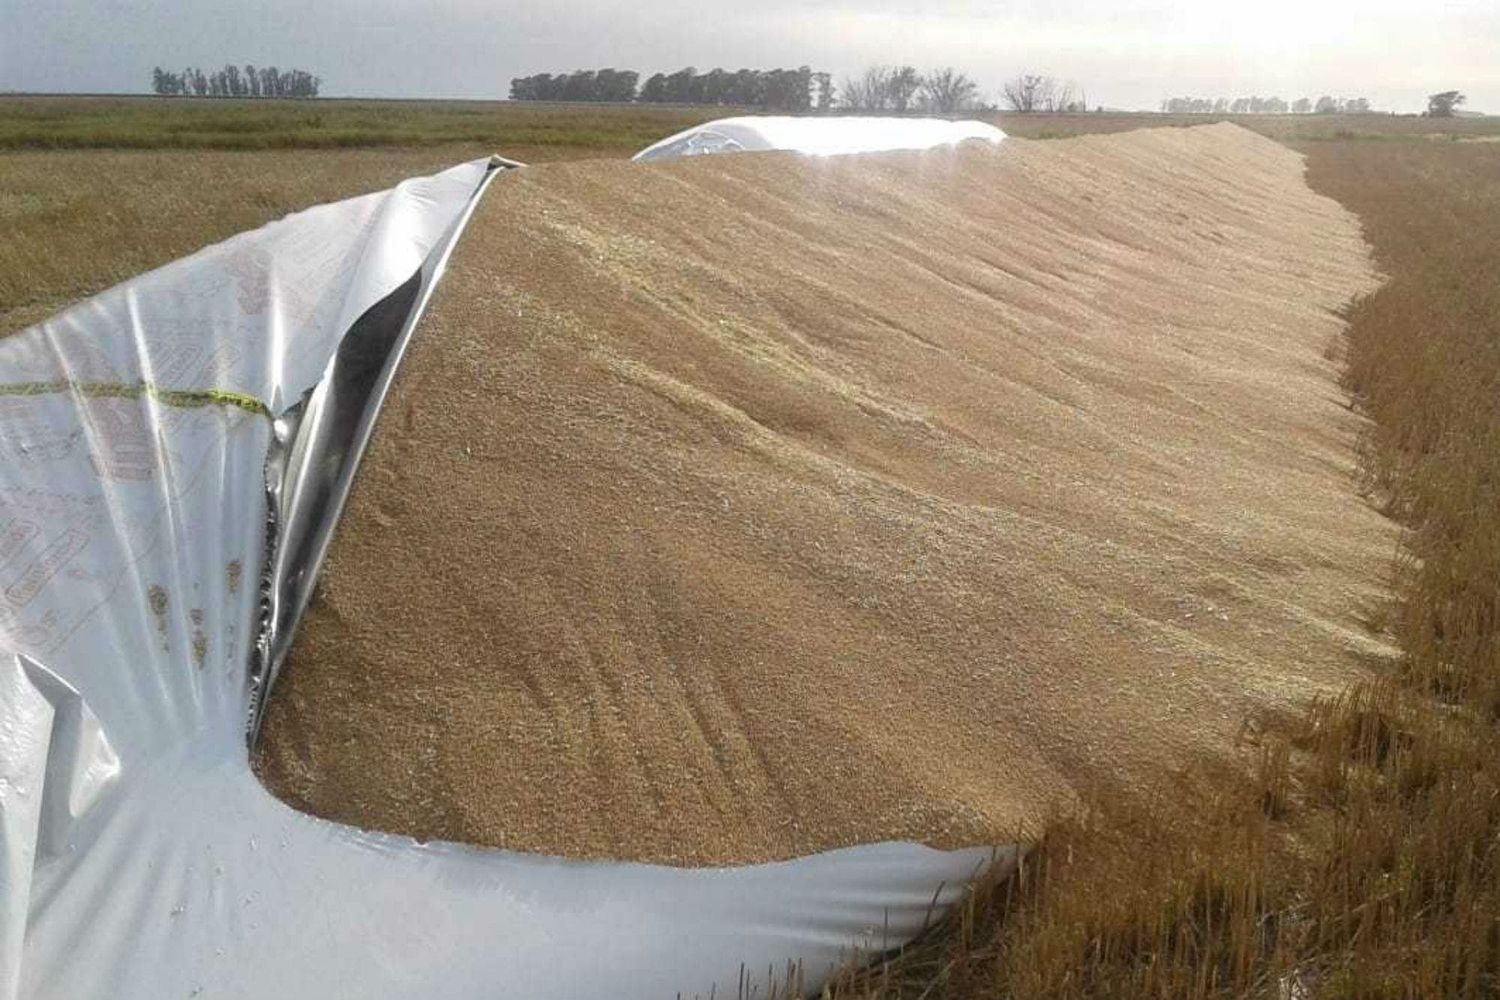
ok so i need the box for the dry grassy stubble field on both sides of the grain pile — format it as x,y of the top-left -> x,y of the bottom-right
0,99 -> 1500,1000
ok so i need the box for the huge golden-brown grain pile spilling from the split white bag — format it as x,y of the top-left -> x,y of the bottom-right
258,126 -> 1392,864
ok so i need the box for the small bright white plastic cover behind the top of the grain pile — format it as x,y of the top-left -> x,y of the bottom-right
633,115 -> 1005,160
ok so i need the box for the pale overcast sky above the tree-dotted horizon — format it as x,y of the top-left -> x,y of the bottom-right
0,0 -> 1500,112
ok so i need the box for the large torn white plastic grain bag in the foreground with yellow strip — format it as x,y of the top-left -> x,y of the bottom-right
0,160 -> 1013,1000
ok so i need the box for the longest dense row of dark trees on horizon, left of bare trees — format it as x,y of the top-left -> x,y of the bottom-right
510,66 -> 834,111
